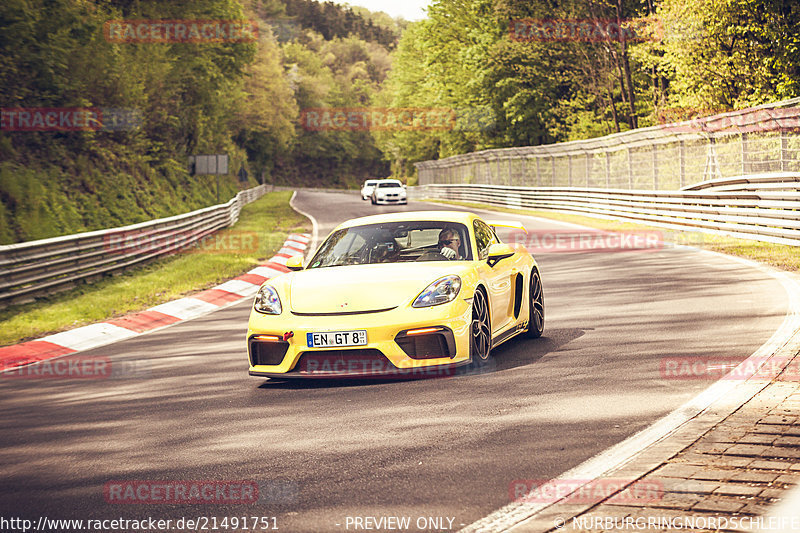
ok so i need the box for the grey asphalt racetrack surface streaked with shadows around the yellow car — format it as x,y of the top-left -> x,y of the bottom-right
0,192 -> 786,532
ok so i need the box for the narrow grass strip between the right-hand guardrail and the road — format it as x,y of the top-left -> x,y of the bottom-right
430,200 -> 800,272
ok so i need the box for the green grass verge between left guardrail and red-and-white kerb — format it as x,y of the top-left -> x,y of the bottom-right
0,191 -> 311,346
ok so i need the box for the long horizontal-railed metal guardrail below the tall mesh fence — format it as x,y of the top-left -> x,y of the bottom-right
413,178 -> 800,246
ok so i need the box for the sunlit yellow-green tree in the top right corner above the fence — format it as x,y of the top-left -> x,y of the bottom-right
645,0 -> 800,110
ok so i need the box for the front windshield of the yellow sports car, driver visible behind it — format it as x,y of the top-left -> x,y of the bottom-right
308,221 -> 472,268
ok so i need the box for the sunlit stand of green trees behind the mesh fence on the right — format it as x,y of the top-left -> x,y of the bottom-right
379,0 -> 800,173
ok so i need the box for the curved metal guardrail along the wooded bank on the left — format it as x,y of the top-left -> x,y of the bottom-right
0,185 -> 268,308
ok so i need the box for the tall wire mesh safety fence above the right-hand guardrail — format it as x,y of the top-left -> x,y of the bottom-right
415,98 -> 800,190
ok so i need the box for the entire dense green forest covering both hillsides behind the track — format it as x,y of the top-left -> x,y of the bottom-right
0,0 -> 800,244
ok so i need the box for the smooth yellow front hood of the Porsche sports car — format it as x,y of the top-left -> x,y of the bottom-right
289,262 -> 466,314
